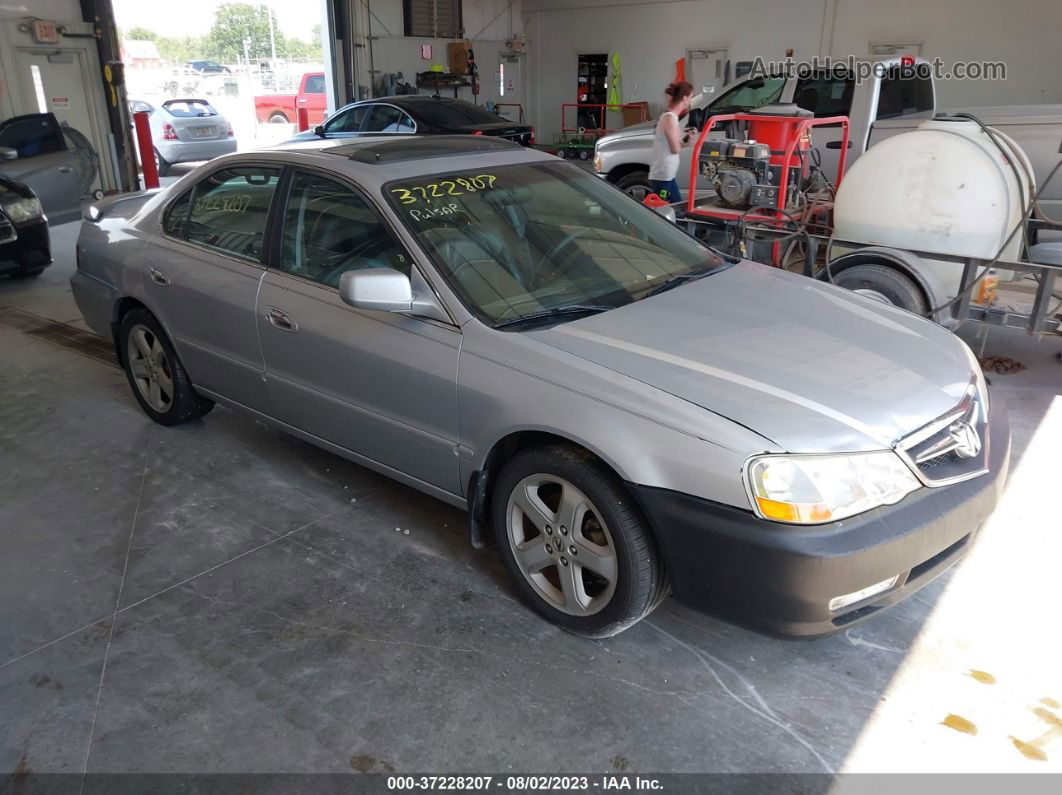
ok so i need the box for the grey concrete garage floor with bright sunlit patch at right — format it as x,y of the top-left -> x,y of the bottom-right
6,217 -> 1062,781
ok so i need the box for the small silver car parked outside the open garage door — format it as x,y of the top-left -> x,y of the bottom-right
130,99 -> 236,176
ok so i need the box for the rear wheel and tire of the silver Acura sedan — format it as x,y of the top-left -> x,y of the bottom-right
118,309 -> 213,426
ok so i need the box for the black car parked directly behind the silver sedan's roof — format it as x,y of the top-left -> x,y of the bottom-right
291,93 -> 534,146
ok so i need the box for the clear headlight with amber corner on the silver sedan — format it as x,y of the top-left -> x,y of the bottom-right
746,450 -> 920,524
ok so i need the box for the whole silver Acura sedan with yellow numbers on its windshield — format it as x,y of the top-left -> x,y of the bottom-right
72,136 -> 1010,637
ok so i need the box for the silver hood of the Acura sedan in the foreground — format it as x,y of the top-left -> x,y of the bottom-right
529,261 -> 973,452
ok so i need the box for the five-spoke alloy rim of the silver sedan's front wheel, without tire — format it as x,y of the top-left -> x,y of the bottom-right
506,473 -> 619,616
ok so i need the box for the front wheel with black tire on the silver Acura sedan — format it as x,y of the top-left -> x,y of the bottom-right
491,445 -> 667,638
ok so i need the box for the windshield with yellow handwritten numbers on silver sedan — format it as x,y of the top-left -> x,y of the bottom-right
383,163 -> 724,325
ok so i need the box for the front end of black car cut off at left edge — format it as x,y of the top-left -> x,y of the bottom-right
0,174 -> 52,277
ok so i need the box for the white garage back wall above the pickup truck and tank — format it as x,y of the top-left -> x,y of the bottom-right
522,0 -> 1062,140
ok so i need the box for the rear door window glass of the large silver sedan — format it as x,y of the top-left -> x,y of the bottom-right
187,166 -> 280,262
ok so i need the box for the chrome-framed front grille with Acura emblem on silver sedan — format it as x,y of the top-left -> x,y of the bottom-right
895,383 -> 989,486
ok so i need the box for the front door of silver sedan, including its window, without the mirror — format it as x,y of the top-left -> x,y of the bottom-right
258,171 -> 461,492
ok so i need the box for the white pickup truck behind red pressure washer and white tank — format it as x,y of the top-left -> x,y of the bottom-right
594,58 -> 1062,218
